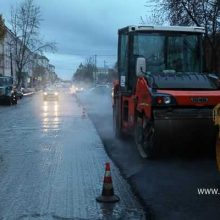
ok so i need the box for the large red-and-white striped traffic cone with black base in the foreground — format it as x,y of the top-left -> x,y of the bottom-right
96,163 -> 120,202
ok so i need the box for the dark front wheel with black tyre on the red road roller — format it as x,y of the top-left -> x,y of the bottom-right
135,117 -> 155,158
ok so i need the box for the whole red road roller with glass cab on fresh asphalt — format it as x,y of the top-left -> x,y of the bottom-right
113,26 -> 220,157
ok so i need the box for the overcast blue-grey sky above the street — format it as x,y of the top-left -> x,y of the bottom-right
0,0 -> 150,79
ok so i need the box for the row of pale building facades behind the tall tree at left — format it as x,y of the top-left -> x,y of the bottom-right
0,28 -> 56,87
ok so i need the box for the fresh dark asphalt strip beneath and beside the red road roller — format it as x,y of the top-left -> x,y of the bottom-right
79,90 -> 220,220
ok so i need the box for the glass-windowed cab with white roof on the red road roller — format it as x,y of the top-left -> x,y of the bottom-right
118,26 -> 204,91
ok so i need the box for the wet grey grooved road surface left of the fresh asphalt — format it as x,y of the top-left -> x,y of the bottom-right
0,94 -> 145,220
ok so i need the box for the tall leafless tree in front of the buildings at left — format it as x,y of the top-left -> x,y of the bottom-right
10,0 -> 55,86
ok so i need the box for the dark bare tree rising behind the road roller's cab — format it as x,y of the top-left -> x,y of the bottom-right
144,0 -> 220,72
